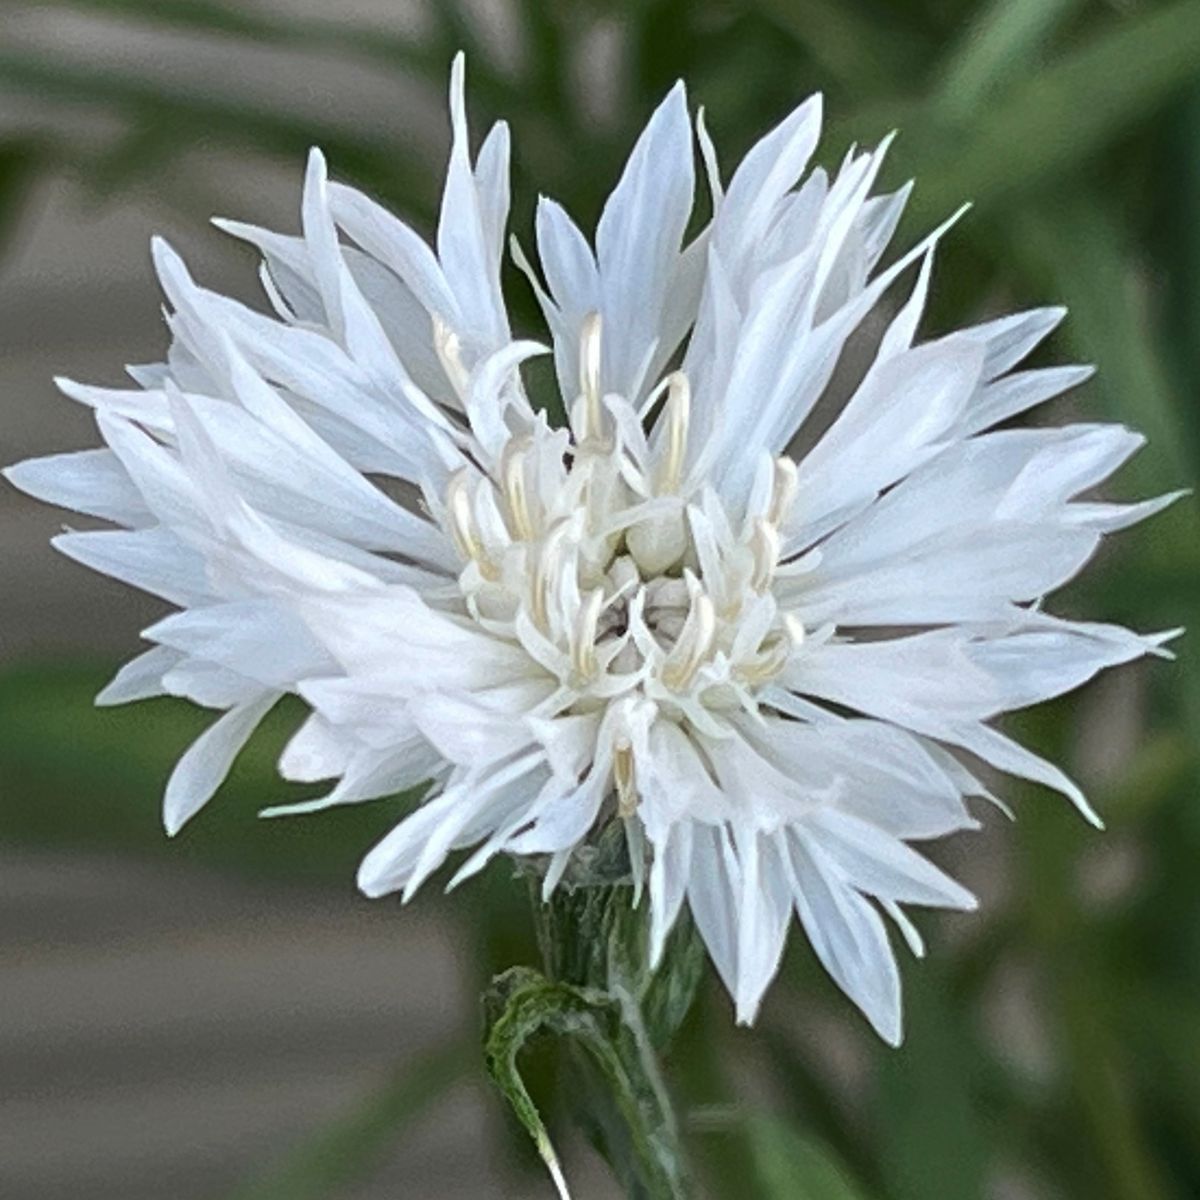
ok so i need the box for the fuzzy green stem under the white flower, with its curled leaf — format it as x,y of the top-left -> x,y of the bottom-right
485,830 -> 703,1200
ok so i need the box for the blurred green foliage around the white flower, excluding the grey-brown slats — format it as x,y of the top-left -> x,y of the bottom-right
0,0 -> 1200,1200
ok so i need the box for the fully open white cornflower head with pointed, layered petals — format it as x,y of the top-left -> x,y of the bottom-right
8,60 -> 1171,1042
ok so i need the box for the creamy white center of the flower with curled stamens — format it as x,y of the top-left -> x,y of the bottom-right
443,314 -> 803,728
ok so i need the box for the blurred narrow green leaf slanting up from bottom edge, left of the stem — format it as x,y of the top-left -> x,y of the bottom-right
229,1045 -> 474,1200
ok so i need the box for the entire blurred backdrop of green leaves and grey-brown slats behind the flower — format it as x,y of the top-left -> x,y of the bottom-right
0,0 -> 1200,1200
